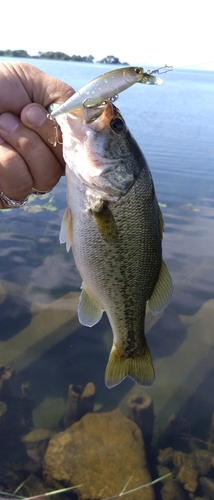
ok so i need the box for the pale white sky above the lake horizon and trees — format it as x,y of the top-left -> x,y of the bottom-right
0,0 -> 214,70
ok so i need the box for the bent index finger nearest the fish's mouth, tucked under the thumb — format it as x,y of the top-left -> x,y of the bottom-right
21,104 -> 65,169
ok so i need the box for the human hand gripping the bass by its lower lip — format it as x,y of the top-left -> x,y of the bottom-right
0,62 -> 74,208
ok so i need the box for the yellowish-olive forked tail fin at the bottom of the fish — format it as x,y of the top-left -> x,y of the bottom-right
105,344 -> 155,389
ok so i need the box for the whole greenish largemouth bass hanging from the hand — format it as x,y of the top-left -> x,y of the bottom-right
57,101 -> 172,388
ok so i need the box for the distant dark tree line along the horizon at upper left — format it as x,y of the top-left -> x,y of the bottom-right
0,49 -> 128,65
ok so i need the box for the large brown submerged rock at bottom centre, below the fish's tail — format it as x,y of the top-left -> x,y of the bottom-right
43,409 -> 154,500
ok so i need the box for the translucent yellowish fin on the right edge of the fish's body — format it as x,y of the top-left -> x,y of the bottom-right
148,260 -> 173,316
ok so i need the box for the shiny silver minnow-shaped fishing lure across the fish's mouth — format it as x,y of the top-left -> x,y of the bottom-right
51,67 -> 163,118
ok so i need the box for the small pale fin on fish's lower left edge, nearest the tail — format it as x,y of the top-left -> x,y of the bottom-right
78,285 -> 103,326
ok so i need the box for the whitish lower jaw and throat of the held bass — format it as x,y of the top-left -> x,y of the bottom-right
59,100 -> 130,201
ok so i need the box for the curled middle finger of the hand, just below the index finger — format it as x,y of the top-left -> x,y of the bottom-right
0,113 -> 63,193
